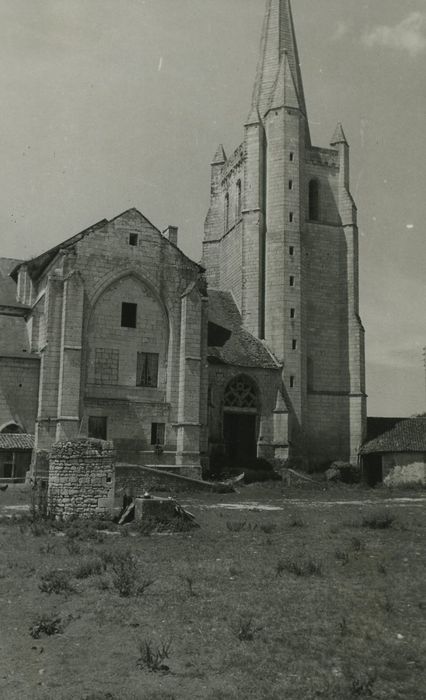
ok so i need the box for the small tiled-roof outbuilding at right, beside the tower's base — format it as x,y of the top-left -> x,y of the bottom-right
360,415 -> 426,486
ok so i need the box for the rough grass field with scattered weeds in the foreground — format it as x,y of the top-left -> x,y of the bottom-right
0,485 -> 426,700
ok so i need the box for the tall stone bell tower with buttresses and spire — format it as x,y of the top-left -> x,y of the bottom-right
204,0 -> 366,470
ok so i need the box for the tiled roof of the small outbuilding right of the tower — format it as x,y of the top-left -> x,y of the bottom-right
360,416 -> 426,454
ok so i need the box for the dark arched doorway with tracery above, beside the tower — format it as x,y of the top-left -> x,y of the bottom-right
223,375 -> 259,466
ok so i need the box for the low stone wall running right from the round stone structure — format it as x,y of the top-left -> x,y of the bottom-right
115,464 -> 215,496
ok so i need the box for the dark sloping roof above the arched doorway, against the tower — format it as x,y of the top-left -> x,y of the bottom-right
208,289 -> 280,369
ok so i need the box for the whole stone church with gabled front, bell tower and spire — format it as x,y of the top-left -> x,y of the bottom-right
0,0 -> 366,476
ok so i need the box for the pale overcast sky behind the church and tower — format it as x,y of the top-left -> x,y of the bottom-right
0,0 -> 426,416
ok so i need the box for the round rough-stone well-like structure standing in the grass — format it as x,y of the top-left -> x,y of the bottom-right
47,438 -> 115,519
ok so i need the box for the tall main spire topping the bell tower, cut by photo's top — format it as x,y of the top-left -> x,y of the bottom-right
252,0 -> 306,116
